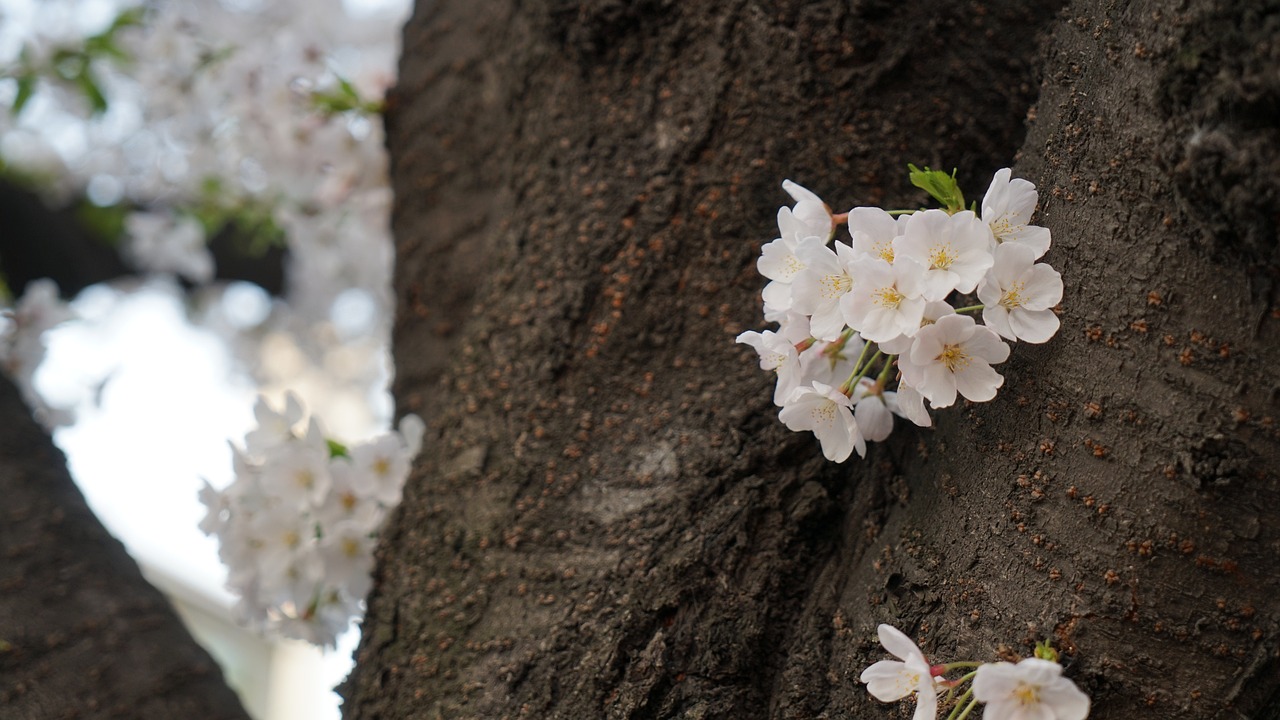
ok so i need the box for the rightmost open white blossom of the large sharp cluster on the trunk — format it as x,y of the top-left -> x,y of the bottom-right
978,242 -> 1062,343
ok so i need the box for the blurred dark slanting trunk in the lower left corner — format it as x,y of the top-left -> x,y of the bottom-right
0,368 -> 248,720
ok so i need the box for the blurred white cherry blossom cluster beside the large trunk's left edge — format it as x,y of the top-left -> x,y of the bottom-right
200,395 -> 424,646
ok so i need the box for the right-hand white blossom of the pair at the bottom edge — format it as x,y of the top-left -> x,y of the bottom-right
973,657 -> 1089,720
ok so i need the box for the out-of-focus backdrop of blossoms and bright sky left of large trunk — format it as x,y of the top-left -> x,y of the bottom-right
0,0 -> 408,720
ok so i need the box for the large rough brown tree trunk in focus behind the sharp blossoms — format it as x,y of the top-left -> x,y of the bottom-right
343,0 -> 1280,720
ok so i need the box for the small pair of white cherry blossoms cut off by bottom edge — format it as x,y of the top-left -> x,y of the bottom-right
859,625 -> 1089,720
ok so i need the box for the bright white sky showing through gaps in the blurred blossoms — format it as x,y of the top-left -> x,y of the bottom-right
0,0 -> 410,707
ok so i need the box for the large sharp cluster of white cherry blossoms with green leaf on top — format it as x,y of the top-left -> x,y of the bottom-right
737,167 -> 1062,462
